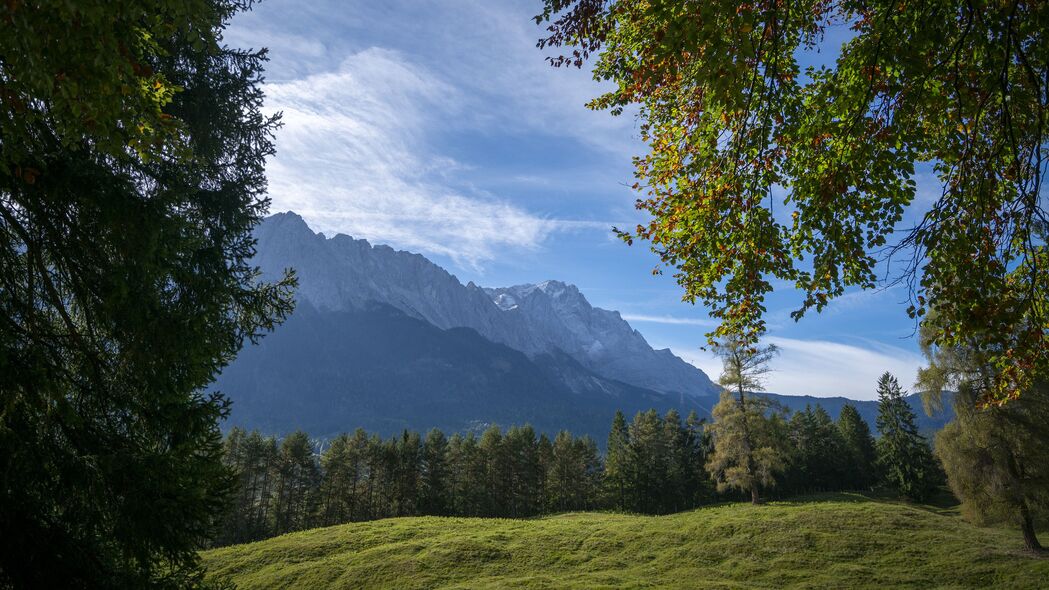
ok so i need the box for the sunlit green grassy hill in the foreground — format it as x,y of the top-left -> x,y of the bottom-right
204,494 -> 1049,589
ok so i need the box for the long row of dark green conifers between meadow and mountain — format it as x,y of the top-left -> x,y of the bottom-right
212,367 -> 938,545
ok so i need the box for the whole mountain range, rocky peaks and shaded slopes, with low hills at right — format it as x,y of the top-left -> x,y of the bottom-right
216,213 -> 944,442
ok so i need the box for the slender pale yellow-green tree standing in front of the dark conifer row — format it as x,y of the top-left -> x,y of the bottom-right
707,338 -> 785,504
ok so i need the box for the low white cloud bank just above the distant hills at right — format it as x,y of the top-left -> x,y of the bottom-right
673,336 -> 923,399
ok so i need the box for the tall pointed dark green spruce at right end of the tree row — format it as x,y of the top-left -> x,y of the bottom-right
877,372 -> 937,502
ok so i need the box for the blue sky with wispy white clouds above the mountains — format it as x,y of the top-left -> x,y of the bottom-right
226,0 -> 935,399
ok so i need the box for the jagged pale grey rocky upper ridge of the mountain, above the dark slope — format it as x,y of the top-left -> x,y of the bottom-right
255,213 -> 718,396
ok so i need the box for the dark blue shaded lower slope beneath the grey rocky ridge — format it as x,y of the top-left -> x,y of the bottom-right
217,302 -> 705,444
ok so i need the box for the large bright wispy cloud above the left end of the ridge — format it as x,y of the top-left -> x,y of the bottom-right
265,48 -> 608,266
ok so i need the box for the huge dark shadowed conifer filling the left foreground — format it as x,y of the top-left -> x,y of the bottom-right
0,0 -> 292,588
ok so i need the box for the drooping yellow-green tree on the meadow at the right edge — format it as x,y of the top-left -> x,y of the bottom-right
919,325 -> 1049,552
